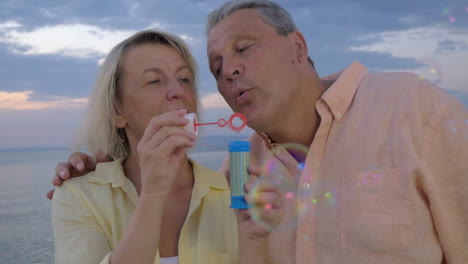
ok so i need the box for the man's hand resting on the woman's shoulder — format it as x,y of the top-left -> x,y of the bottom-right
47,151 -> 111,199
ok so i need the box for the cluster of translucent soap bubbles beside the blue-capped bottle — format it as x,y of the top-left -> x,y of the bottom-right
249,143 -> 336,229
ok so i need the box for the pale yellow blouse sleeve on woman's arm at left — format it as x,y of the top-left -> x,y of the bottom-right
52,182 -> 111,264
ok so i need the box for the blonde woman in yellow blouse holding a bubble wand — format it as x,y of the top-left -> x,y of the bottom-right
52,31 -> 238,264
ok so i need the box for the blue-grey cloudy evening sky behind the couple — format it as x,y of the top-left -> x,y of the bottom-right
0,0 -> 468,149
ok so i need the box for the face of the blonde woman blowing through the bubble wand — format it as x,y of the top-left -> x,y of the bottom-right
116,44 -> 197,141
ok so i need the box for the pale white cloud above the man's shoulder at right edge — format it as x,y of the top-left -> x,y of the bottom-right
350,26 -> 468,91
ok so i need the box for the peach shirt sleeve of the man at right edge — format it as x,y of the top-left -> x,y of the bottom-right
423,99 -> 468,264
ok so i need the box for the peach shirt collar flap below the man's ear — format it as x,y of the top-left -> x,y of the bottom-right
321,61 -> 368,122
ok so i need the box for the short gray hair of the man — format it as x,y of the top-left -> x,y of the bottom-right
206,0 -> 315,67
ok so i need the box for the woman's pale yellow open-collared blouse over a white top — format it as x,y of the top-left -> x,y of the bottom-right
52,161 -> 238,264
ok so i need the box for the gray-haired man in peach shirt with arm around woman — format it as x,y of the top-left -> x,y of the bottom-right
49,0 -> 468,264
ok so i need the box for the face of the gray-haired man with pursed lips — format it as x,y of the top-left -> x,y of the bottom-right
207,9 -> 299,132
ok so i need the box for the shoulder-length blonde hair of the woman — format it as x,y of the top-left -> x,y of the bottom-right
76,30 -> 198,160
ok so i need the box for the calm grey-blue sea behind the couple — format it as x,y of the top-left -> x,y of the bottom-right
0,141 -> 233,264
